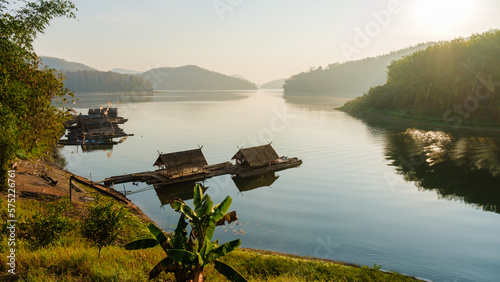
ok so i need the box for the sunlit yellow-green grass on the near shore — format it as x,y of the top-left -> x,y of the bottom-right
0,193 -> 414,281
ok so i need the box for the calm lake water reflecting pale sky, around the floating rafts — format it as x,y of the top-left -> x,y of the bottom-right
62,90 -> 500,281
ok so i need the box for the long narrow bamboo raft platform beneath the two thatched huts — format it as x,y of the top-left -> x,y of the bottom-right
100,158 -> 302,187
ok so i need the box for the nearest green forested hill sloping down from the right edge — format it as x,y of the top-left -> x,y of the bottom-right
342,30 -> 500,123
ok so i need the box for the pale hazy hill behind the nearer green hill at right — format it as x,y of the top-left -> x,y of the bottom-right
283,43 -> 435,98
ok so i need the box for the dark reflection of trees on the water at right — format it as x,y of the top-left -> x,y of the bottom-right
386,129 -> 500,212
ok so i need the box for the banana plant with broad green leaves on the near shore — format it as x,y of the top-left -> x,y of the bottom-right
125,185 -> 247,282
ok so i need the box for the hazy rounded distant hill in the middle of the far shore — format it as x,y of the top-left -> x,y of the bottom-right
142,66 -> 257,90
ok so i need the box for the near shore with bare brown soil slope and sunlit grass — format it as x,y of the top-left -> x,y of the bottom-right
0,160 -> 414,281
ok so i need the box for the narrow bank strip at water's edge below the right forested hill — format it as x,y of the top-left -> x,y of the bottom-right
336,107 -> 500,134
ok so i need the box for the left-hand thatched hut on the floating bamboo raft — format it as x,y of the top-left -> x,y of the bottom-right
154,149 -> 208,174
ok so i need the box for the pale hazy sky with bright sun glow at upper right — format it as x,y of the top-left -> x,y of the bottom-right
35,0 -> 500,83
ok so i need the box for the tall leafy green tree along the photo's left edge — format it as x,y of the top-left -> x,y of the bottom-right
0,0 -> 76,188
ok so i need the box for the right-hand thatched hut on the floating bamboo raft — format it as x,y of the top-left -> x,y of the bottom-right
232,144 -> 279,168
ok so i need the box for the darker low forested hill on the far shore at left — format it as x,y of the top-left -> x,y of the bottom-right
63,70 -> 153,92
